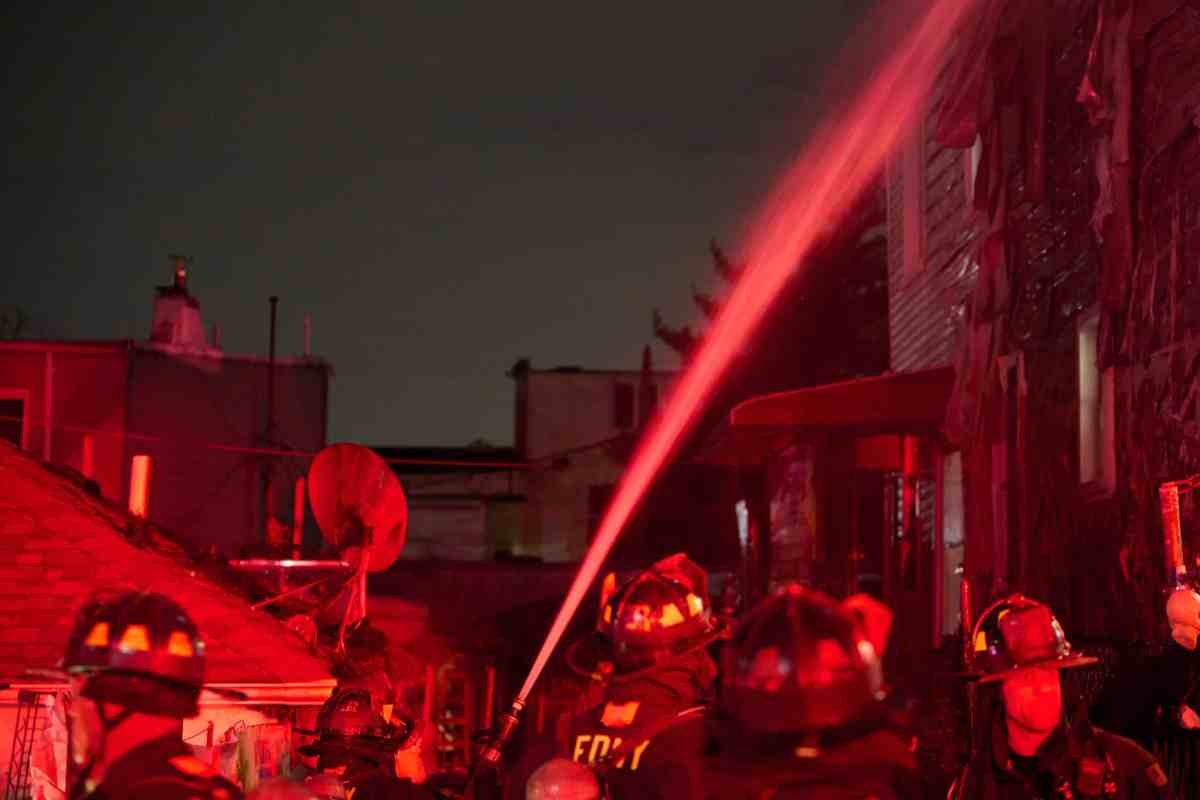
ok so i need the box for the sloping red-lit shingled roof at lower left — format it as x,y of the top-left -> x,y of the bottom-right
0,440 -> 332,685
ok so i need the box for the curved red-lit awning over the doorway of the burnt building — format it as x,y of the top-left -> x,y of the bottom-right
696,367 -> 954,465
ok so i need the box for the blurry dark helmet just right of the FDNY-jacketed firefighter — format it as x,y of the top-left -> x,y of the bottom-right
720,584 -> 883,739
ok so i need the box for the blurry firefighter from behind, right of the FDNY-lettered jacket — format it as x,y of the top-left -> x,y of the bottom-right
706,584 -> 920,800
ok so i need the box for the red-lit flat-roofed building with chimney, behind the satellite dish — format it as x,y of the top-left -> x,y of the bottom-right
0,267 -> 330,555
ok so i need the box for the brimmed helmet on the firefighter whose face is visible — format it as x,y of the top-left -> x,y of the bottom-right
967,594 -> 1097,682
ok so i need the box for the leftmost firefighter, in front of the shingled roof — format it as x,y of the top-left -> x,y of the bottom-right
62,591 -> 242,800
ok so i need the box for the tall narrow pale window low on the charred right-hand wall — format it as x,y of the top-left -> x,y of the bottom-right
1075,312 -> 1116,495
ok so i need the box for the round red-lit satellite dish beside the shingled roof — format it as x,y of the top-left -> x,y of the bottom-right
308,444 -> 408,572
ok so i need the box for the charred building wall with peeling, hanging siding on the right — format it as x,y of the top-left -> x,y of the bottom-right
889,0 -> 1200,640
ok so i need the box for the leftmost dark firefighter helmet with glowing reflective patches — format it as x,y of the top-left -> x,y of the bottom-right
62,591 -> 205,718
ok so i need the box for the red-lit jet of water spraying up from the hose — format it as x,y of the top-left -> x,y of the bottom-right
514,0 -> 977,711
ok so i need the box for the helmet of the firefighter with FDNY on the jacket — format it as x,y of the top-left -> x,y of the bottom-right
565,553 -> 724,681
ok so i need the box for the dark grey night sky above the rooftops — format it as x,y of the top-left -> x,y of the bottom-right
0,0 -> 871,445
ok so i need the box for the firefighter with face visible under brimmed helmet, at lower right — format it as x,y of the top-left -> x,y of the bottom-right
952,595 -> 1174,800
